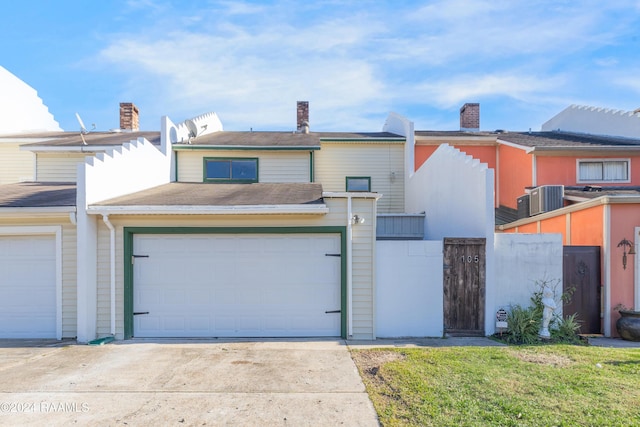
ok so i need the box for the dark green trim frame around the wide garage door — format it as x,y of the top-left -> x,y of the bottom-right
123,226 -> 348,339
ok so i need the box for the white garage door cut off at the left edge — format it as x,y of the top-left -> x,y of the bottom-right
0,236 -> 56,338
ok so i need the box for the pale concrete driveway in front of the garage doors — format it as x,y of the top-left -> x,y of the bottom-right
0,340 -> 378,426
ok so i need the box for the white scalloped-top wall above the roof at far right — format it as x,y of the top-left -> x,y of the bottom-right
542,105 -> 640,138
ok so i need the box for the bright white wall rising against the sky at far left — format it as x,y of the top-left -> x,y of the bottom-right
0,66 -> 62,135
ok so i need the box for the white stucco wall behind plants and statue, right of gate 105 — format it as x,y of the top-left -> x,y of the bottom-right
487,233 -> 562,334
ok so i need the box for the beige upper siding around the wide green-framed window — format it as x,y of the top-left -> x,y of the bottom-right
177,150 -> 311,182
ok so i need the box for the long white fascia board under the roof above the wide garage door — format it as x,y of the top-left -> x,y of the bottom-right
87,204 -> 329,215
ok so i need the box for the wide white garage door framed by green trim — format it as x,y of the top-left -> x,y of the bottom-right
133,234 -> 341,337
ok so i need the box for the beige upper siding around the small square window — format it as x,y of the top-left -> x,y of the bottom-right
314,142 -> 405,213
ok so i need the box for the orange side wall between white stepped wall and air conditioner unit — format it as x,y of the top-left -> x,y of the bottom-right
496,145 -> 533,209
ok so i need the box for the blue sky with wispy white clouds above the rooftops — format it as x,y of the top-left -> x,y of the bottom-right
0,0 -> 640,131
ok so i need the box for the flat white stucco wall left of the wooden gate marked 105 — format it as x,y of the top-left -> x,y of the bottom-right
376,240 -> 443,338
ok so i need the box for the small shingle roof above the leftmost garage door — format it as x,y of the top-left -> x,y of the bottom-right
0,182 -> 76,208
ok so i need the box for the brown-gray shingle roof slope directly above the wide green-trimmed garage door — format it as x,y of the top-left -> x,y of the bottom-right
94,182 -> 323,206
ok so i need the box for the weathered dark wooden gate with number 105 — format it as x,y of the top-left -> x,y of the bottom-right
444,238 -> 486,336
